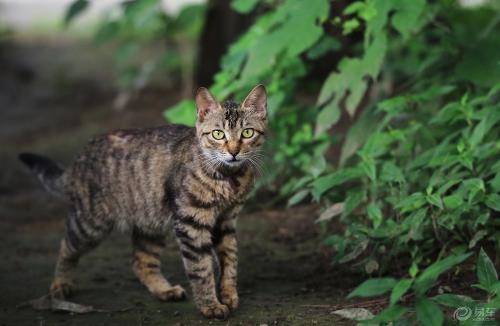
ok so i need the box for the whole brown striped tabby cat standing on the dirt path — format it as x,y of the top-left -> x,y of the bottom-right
20,85 -> 267,318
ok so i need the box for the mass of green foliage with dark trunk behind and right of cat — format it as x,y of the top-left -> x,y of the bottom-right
56,0 -> 500,324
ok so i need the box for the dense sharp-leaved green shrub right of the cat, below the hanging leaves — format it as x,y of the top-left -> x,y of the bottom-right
311,83 -> 500,272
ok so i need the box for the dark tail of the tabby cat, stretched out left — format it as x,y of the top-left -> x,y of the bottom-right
19,153 -> 64,196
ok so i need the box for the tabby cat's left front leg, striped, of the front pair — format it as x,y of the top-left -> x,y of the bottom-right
174,215 -> 229,319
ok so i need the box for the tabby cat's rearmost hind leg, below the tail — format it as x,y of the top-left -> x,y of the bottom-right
50,209 -> 113,298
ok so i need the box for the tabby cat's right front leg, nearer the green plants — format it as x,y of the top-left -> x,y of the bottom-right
212,207 -> 241,310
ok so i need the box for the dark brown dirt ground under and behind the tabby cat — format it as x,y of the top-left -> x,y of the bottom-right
0,39 -> 357,326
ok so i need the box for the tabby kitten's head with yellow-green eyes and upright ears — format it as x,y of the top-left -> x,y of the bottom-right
196,85 -> 267,168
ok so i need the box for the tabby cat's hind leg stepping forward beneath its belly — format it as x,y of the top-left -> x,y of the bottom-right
132,228 -> 186,301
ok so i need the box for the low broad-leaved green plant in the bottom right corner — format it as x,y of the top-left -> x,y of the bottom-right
348,249 -> 500,326
